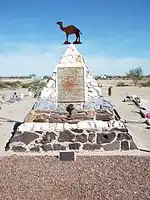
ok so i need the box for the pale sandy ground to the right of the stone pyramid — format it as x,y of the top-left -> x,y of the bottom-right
103,86 -> 150,151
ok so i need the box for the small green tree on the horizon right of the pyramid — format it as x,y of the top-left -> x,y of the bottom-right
127,67 -> 143,85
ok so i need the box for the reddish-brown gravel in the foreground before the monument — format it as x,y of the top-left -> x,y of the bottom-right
0,156 -> 150,200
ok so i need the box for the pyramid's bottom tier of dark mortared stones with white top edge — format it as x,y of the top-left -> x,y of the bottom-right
7,121 -> 137,152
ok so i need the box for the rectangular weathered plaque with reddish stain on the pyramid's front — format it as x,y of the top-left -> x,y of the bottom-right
57,67 -> 85,103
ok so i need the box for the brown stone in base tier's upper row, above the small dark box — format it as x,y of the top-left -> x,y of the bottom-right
58,130 -> 75,142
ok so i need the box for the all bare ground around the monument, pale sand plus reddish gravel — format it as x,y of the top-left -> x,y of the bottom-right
0,80 -> 150,200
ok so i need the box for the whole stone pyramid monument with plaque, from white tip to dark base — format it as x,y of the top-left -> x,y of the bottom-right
6,44 -> 137,153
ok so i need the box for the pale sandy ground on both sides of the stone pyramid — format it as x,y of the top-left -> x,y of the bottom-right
0,83 -> 150,152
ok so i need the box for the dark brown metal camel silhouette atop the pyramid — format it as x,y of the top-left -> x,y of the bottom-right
57,21 -> 82,44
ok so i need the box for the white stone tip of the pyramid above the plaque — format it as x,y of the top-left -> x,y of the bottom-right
55,44 -> 88,72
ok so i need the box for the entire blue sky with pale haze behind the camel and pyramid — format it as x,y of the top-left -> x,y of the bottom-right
0,0 -> 150,76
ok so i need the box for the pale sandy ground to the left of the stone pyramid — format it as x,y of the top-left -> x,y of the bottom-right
0,90 -> 35,155
